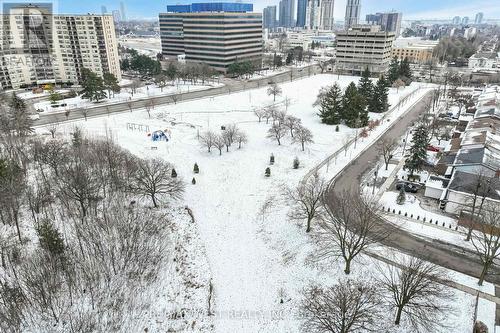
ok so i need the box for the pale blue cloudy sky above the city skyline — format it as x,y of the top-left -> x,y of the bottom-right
16,0 -> 500,21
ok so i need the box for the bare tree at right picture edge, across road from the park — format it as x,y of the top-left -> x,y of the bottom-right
472,203 -> 500,286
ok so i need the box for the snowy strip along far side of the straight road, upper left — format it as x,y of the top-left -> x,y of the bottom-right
34,83 -> 221,112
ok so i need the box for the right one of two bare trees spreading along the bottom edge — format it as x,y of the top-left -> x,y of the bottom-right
378,257 -> 452,332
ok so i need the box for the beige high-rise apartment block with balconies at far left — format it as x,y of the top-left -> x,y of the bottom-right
0,4 -> 121,90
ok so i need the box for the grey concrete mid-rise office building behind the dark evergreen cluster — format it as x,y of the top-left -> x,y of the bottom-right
337,25 -> 395,75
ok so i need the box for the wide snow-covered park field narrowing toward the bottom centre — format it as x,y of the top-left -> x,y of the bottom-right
39,75 -> 491,333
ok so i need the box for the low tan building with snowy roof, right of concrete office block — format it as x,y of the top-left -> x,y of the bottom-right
392,38 -> 439,64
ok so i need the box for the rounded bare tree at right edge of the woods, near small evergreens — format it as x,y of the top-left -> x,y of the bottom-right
131,159 -> 184,208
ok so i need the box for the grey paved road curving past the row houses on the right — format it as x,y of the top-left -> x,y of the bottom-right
328,93 -> 500,284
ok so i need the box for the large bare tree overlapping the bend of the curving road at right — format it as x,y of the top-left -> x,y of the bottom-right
317,192 -> 386,274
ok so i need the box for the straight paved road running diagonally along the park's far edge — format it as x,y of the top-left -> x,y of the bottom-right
35,65 -> 319,126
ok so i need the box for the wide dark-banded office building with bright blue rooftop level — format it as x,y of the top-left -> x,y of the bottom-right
160,3 -> 263,72
